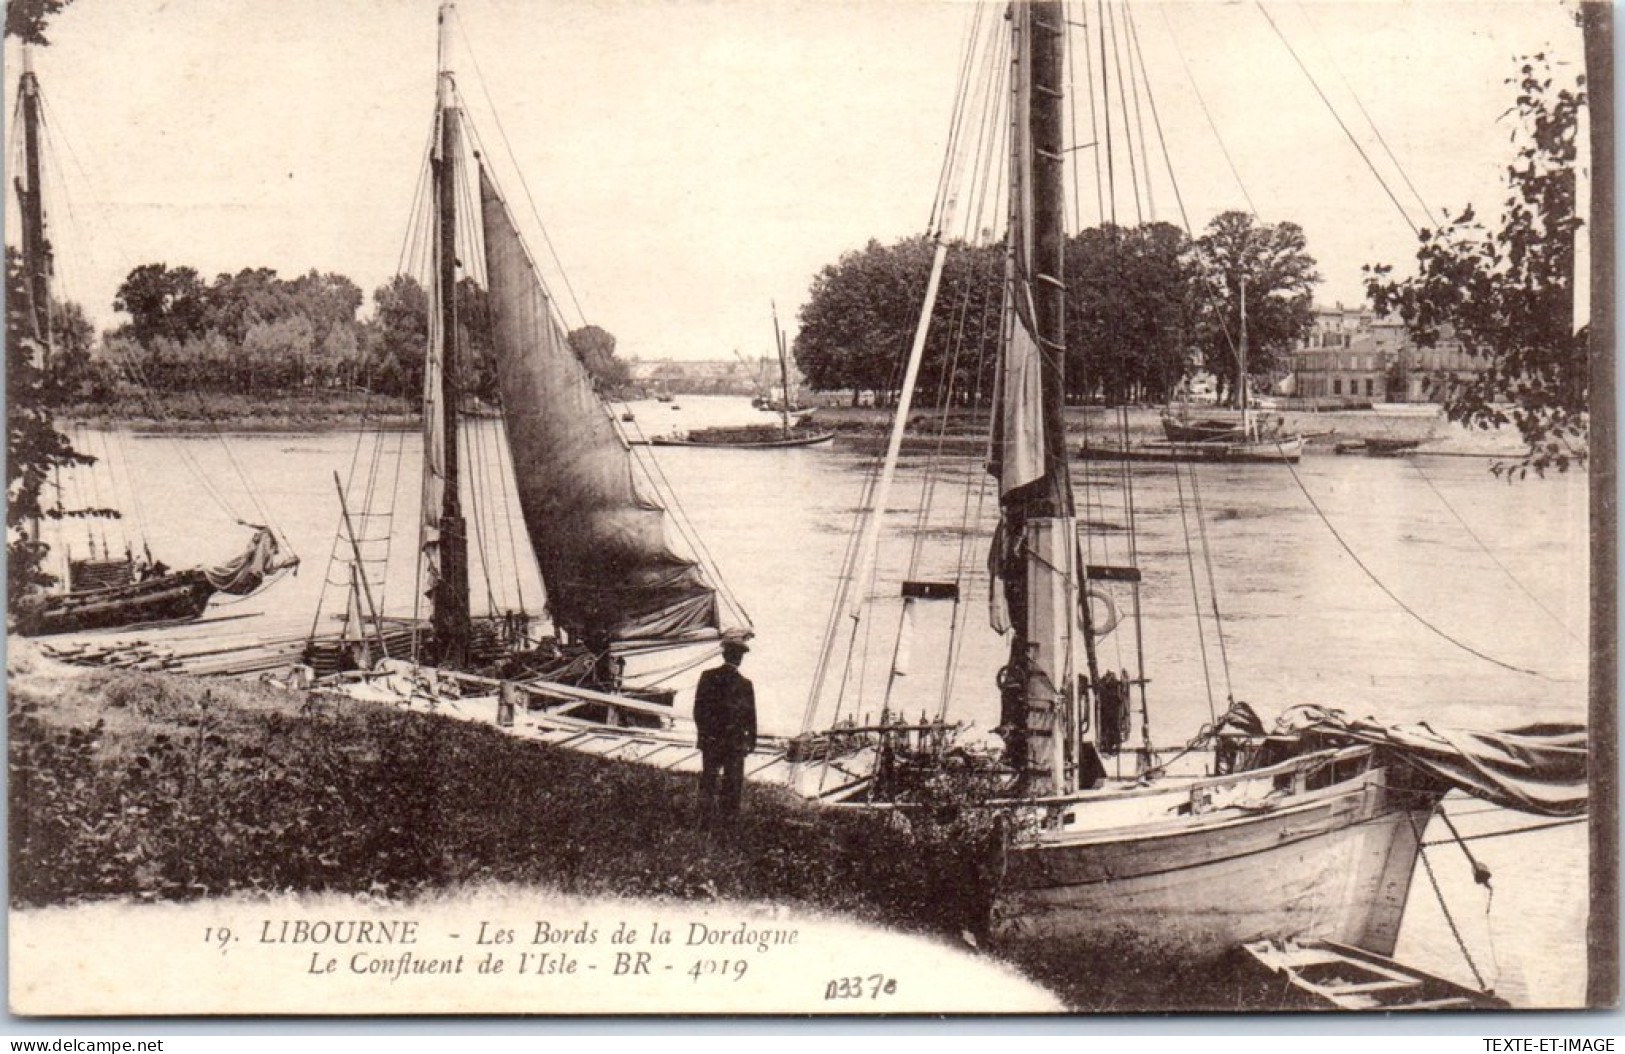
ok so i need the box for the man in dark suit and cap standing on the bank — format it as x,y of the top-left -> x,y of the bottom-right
694,630 -> 756,830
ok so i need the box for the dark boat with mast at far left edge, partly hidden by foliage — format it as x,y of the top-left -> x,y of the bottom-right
11,44 -> 299,637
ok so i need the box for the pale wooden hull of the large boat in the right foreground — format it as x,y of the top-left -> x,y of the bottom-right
991,765 -> 1438,965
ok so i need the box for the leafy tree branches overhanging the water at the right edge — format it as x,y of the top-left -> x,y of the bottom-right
1365,54 -> 1589,474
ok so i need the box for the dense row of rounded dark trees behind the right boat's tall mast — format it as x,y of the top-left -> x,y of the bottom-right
796,211 -> 1320,404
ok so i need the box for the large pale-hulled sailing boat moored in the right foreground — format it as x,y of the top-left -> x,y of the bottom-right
791,0 -> 1584,970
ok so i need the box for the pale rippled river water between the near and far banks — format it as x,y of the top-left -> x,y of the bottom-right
44,396 -> 1589,1005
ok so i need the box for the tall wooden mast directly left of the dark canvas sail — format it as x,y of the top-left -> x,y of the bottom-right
431,3 -> 470,667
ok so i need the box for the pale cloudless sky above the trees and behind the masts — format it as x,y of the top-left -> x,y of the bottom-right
5,0 -> 1581,361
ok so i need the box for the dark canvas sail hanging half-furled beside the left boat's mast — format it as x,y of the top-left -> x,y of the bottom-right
479,169 -> 718,643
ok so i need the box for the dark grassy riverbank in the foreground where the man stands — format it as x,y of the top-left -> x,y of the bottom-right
8,638 -> 1306,1010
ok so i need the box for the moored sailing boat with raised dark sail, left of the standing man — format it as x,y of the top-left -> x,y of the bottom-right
306,3 -> 749,728
